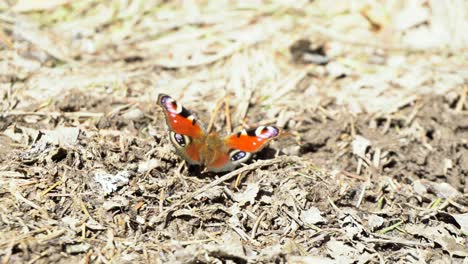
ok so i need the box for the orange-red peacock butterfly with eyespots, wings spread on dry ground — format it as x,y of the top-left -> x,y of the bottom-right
158,94 -> 280,172
